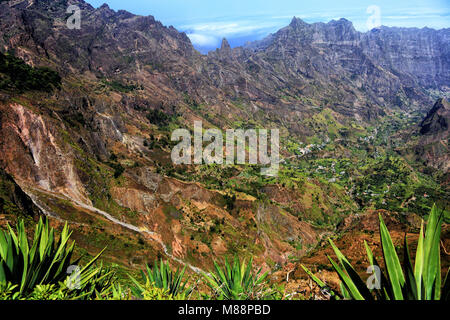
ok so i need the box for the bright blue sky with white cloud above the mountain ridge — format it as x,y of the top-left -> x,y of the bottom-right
87,0 -> 450,53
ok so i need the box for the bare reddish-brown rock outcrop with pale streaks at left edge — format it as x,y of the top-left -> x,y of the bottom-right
0,103 -> 90,203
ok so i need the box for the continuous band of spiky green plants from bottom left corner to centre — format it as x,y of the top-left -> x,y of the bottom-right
0,219 -> 276,300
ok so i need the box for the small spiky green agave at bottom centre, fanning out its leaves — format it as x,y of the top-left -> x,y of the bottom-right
203,256 -> 269,300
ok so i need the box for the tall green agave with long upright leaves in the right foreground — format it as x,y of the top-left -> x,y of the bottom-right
302,206 -> 450,300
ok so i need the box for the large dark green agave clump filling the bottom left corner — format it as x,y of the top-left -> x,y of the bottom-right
0,219 -> 111,298
